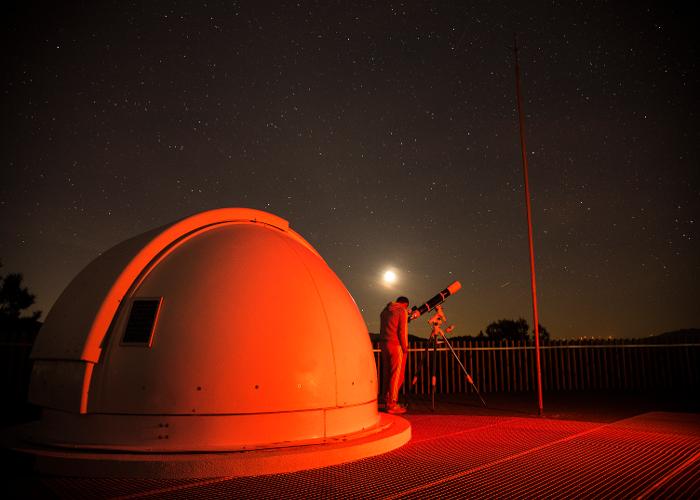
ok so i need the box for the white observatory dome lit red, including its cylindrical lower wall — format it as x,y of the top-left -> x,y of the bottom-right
30,208 -> 410,460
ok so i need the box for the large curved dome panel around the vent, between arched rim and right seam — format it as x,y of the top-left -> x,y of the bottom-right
90,223 -> 340,414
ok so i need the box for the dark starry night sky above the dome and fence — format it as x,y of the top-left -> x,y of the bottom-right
0,1 -> 700,338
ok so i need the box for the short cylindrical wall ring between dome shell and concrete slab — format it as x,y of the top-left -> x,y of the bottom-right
23,400 -> 380,453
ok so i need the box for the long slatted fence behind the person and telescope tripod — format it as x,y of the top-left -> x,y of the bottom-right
374,341 -> 700,394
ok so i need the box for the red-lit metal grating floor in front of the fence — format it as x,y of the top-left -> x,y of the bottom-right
40,412 -> 700,499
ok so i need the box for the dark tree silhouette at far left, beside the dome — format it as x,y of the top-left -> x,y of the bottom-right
0,263 -> 41,340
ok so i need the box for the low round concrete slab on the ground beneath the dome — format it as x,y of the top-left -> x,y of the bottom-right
5,414 -> 411,478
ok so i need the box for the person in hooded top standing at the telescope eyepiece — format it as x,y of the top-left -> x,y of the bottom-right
379,296 -> 408,415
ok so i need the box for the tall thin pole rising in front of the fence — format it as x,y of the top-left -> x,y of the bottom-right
513,35 -> 543,415
